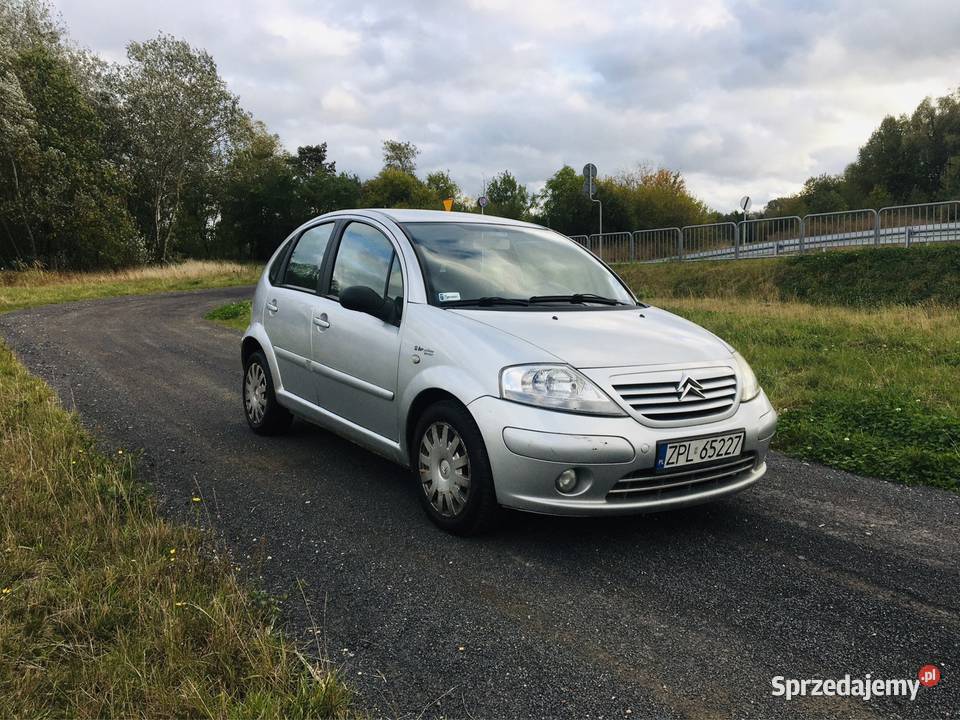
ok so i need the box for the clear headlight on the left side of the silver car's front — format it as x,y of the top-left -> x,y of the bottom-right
500,365 -> 626,415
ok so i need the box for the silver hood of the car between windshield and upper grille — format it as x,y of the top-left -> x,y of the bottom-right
451,307 -> 732,368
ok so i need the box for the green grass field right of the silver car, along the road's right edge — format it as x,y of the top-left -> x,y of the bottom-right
649,298 -> 960,491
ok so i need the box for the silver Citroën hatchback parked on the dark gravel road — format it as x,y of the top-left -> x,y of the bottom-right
242,210 -> 777,534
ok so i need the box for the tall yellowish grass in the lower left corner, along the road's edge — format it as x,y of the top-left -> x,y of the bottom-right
0,347 -> 351,718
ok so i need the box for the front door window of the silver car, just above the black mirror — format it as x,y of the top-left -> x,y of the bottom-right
330,222 -> 403,297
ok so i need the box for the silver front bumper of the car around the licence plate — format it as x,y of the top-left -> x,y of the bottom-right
469,392 -> 777,515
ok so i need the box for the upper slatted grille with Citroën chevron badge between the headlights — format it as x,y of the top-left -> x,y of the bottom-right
613,367 -> 737,425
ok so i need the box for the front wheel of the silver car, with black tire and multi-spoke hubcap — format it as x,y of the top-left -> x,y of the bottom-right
410,400 -> 500,536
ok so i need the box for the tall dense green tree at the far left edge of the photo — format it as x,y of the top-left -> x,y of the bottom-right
0,2 -> 139,269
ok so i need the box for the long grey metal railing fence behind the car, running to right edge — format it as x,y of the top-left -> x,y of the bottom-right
571,200 -> 960,263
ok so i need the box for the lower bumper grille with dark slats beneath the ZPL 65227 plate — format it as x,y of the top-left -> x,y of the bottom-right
607,453 -> 756,502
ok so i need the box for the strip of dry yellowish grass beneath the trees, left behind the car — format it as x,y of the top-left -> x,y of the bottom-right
0,260 -> 262,312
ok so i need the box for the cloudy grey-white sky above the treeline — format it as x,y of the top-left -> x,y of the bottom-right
54,0 -> 960,210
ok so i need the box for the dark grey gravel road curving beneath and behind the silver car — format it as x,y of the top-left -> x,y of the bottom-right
0,288 -> 960,718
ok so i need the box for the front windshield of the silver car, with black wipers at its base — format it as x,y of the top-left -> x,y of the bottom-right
404,222 -> 636,307
